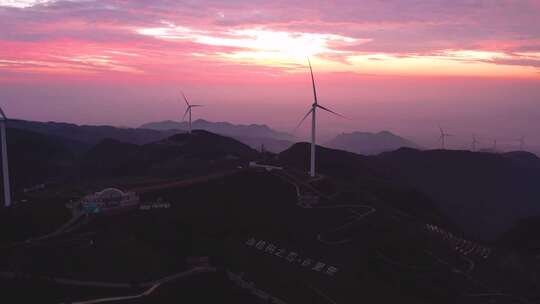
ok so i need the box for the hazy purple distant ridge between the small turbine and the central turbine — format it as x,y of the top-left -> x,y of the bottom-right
141,119 -> 295,153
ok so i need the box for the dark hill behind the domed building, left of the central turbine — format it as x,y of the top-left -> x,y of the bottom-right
1,127 -> 258,192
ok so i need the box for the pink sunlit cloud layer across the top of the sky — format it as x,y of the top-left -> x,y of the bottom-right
0,0 -> 540,78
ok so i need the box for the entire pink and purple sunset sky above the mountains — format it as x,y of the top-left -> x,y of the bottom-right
0,0 -> 540,148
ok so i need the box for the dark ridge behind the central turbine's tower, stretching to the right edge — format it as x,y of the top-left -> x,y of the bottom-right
279,143 -> 540,241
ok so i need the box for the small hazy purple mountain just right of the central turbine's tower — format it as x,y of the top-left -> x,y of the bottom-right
325,131 -> 418,155
